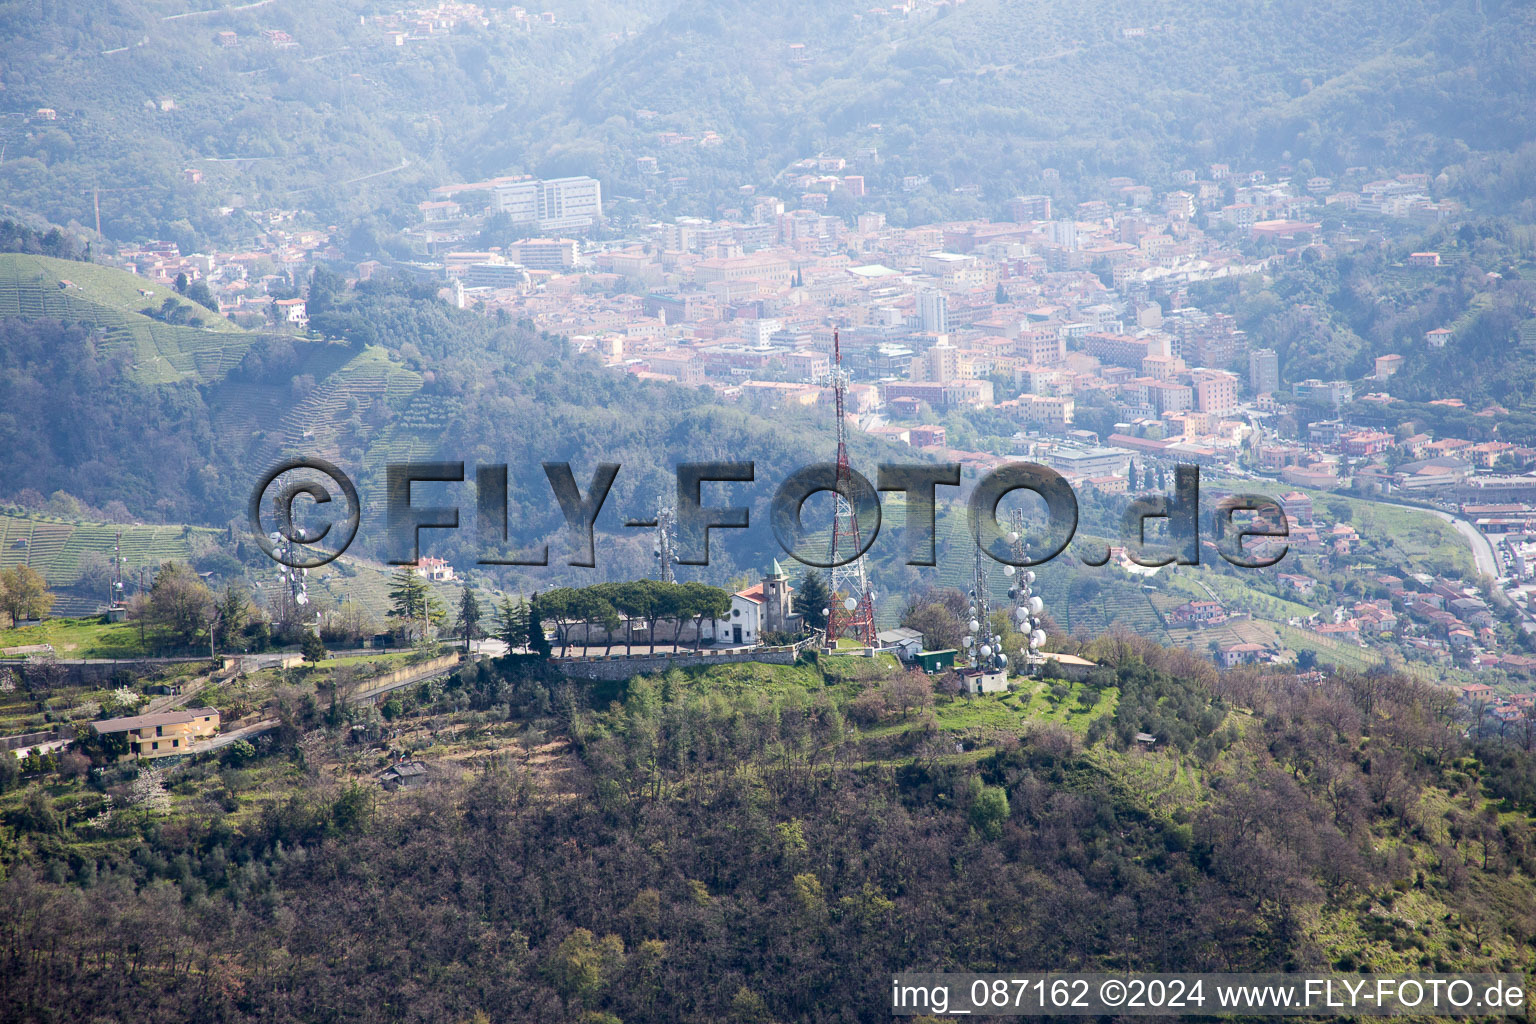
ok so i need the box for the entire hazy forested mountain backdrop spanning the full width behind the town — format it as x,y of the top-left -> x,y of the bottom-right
0,0 -> 1536,248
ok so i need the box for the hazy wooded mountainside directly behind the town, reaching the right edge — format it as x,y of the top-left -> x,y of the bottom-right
481,0 -> 1536,223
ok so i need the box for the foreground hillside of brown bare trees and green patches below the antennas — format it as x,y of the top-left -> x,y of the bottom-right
0,639 -> 1536,1022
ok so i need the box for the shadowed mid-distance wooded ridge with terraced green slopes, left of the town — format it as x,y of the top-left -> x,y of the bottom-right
0,255 -> 915,590
